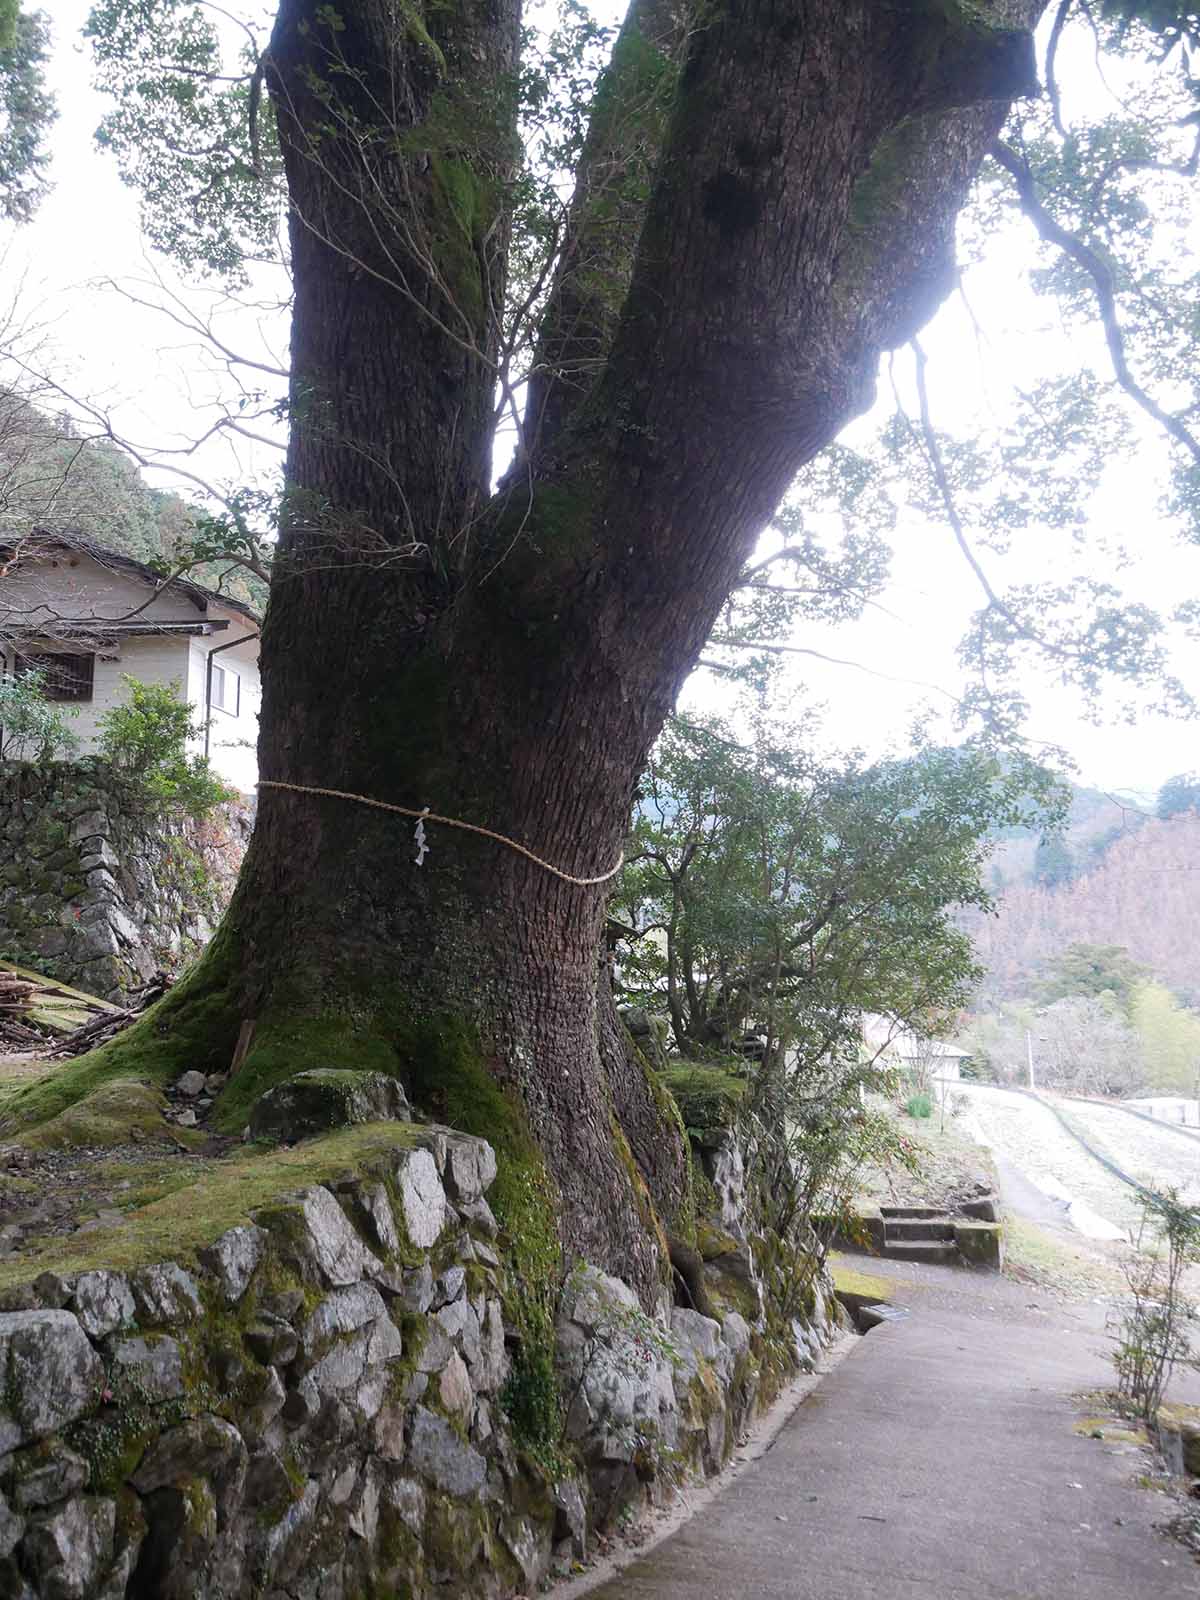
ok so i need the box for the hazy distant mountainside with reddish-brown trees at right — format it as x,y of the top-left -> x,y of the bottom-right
962,812 -> 1200,1005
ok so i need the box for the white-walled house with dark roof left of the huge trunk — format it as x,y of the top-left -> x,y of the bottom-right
0,531 -> 261,790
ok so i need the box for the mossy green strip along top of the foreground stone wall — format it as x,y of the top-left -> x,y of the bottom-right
0,1122 -> 422,1288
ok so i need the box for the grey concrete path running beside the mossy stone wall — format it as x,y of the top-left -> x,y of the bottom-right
579,1261 -> 1200,1600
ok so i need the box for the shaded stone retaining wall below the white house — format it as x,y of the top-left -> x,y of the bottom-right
0,762 -> 253,1000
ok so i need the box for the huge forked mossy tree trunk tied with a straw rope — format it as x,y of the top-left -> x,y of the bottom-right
40,0 -> 1200,1294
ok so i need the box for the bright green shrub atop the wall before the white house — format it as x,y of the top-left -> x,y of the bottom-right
96,677 -> 232,816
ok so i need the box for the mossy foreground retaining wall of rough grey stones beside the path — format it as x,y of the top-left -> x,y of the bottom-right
0,1125 -> 837,1600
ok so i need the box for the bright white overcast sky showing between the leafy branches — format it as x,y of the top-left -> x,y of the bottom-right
9,0 -> 1200,792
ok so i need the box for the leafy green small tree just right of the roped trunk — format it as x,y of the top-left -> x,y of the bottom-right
610,718 -> 1062,1066
